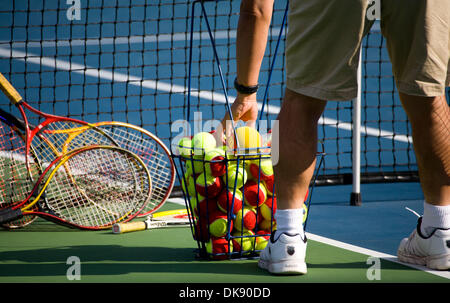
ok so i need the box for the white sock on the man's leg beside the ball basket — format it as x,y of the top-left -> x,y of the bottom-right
274,208 -> 303,240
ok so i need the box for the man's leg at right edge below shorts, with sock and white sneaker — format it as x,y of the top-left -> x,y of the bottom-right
397,93 -> 450,270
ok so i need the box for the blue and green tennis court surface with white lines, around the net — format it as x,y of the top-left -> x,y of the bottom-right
0,0 -> 450,283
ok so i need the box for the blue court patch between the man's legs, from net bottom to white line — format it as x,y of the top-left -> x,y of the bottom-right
307,183 -> 423,255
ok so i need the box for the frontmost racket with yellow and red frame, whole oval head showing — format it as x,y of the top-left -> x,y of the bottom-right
0,146 -> 151,230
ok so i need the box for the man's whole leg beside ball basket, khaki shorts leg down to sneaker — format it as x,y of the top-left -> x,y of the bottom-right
258,0 -> 371,274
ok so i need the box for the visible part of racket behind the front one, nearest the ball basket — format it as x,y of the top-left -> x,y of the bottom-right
53,121 -> 176,217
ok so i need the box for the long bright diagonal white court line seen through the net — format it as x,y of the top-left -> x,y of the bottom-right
0,47 -> 412,143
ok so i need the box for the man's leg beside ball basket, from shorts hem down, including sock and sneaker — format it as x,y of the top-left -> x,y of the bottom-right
258,89 -> 326,274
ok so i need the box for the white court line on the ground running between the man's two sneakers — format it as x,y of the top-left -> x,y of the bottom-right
306,232 -> 450,279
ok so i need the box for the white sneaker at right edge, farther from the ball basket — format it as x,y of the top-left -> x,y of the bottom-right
397,218 -> 450,270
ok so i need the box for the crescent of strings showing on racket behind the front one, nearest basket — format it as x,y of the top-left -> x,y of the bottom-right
101,125 -> 174,212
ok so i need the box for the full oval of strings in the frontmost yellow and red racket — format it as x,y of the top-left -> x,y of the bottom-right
42,149 -> 151,227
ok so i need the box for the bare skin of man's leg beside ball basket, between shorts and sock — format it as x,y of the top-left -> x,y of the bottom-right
274,89 -> 327,209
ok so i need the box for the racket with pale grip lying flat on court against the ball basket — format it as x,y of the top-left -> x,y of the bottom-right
112,209 -> 190,234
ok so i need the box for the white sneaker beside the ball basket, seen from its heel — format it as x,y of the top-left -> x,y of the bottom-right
258,232 -> 307,275
